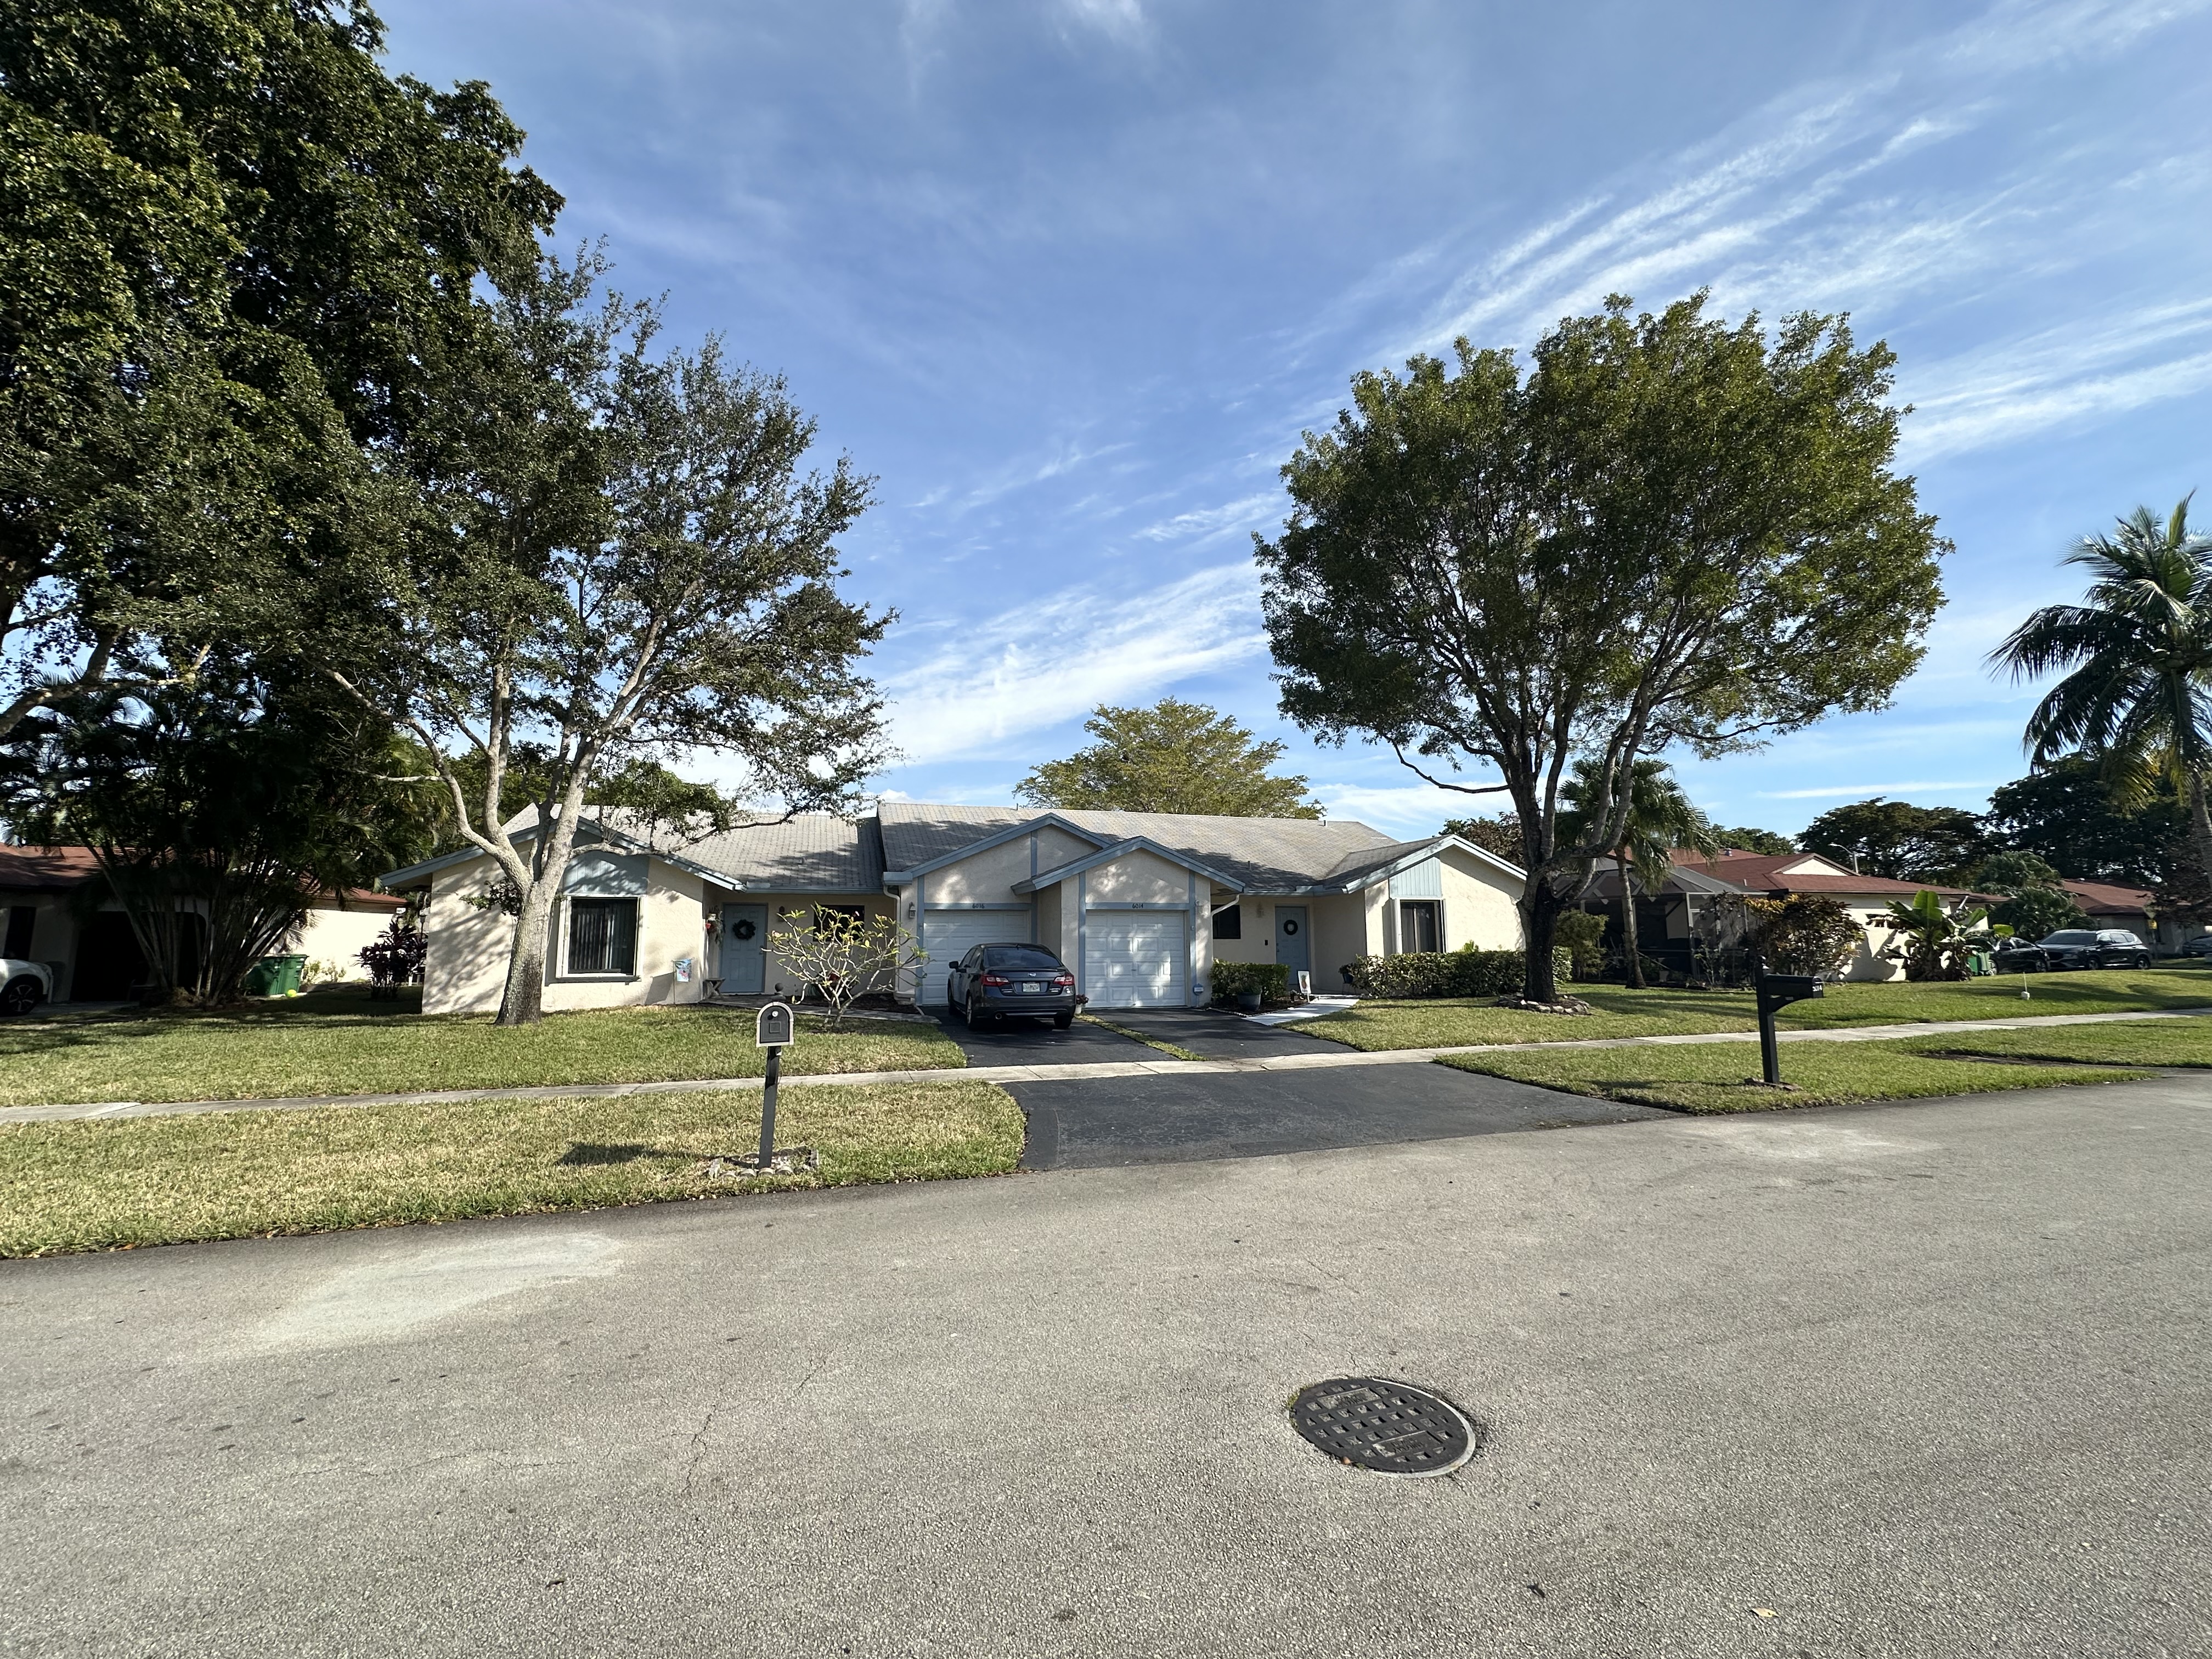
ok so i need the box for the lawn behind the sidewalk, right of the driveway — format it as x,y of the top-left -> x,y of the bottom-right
1299,962 -> 2212,1048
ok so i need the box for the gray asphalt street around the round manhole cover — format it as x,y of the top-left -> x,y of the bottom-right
0,1080 -> 2212,1659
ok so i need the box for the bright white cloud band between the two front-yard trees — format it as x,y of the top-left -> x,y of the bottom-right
883,562 -> 1267,763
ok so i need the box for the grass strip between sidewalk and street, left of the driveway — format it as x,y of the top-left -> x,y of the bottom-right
0,1082 -> 1022,1256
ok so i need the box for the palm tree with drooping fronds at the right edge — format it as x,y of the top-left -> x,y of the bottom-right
1991,495 -> 2212,872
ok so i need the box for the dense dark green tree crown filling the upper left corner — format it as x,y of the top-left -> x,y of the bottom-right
0,0 -> 560,741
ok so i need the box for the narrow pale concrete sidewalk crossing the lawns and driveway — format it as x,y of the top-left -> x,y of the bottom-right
0,1009 -> 2212,1124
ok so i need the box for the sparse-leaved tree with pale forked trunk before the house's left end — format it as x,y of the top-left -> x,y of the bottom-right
323,259 -> 889,1024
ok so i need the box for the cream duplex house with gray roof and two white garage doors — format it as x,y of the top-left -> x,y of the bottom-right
383,801 -> 1522,1013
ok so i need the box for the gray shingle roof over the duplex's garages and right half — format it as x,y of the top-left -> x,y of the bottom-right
878,801 -> 1425,894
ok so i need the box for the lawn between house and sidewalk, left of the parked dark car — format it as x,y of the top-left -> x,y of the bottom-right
0,989 -> 964,1106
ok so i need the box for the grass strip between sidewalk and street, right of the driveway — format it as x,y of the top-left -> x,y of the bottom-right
1438,1033 -> 2150,1113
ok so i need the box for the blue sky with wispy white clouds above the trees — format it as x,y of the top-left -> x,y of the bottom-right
383,0 -> 2212,834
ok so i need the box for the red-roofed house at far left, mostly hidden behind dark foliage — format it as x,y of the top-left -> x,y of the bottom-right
0,845 -> 405,1002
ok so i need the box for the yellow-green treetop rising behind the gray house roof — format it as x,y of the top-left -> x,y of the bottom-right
1013,697 -> 1321,819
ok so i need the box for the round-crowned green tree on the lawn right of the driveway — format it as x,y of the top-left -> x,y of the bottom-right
1256,296 -> 1942,1002
